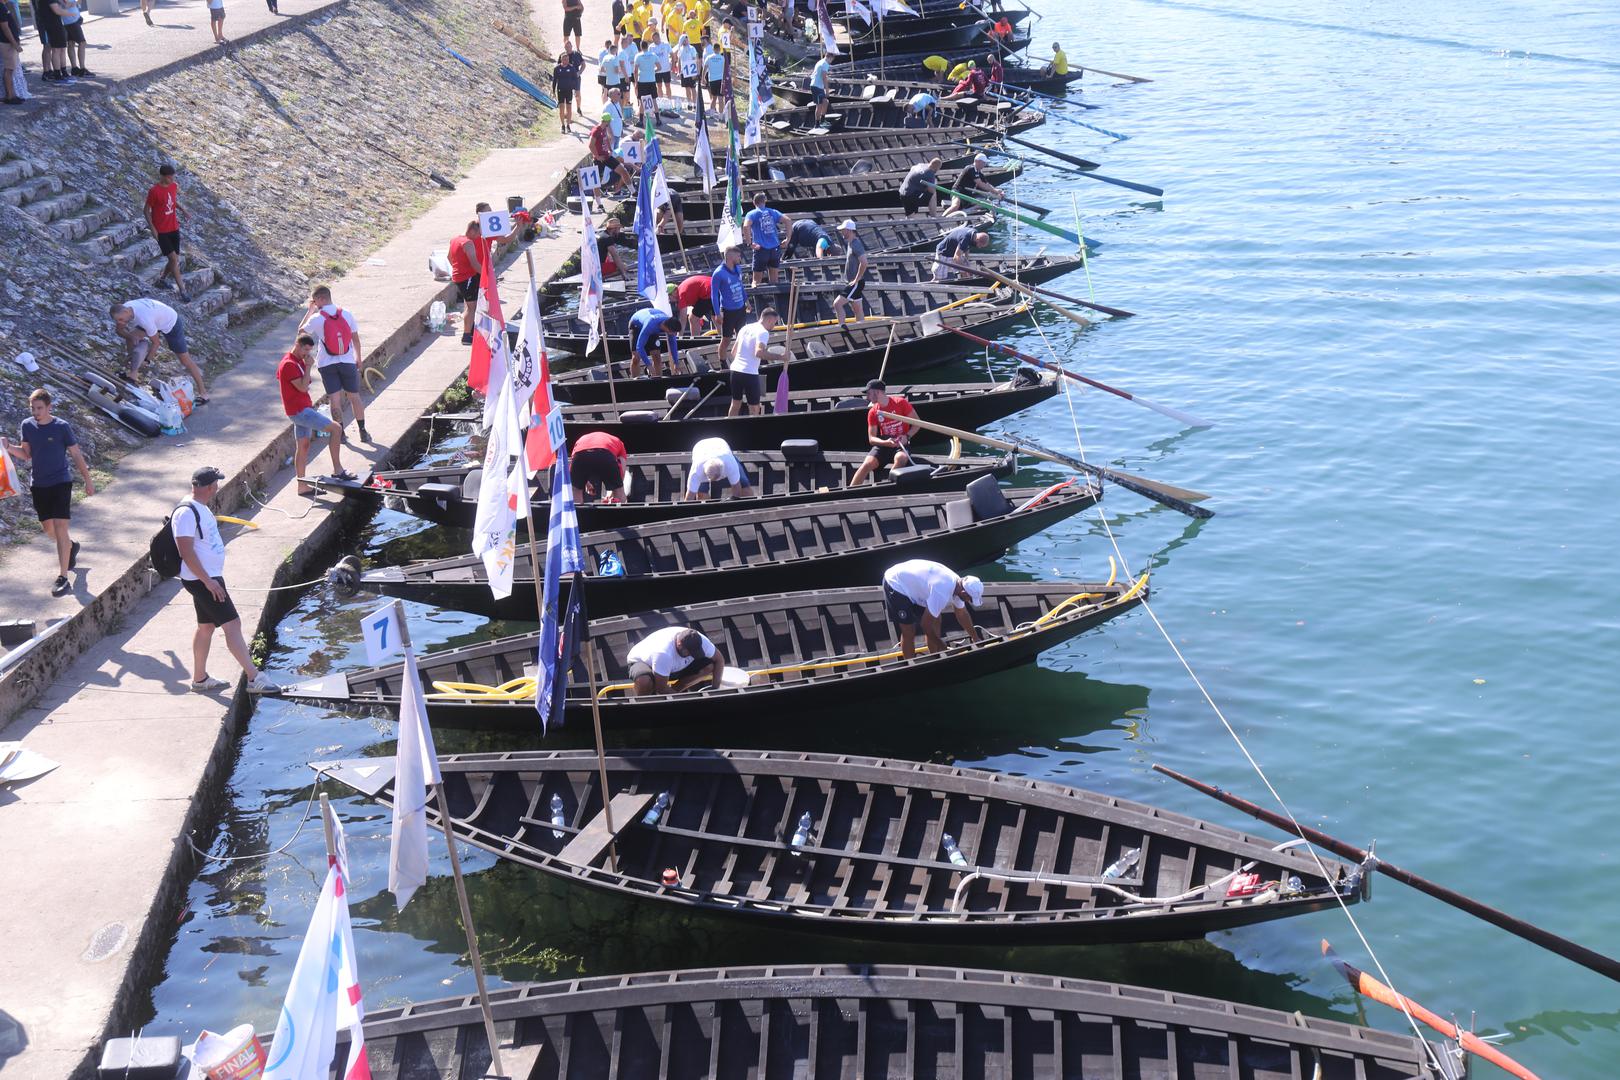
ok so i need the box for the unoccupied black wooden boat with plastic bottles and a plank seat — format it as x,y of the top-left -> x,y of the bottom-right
312,744 -> 1361,945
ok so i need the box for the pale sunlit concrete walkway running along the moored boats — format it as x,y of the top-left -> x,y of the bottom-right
0,0 -> 608,1080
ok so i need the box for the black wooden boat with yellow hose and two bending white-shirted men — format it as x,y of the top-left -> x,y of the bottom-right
280,580 -> 1147,732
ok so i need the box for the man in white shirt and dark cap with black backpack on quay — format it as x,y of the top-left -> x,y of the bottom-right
168,466 -> 280,693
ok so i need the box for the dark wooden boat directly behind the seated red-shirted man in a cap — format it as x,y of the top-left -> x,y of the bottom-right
550,369 -> 1058,452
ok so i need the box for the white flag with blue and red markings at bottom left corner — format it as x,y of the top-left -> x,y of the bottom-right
264,861 -> 370,1080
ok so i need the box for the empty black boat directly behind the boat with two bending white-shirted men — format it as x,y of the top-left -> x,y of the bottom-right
360,476 -> 1102,620
